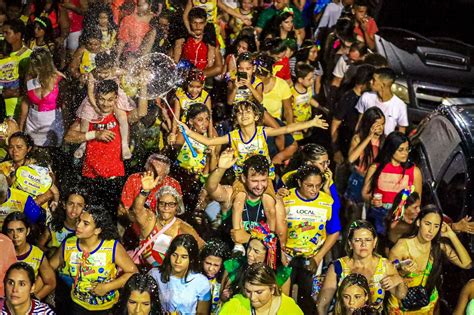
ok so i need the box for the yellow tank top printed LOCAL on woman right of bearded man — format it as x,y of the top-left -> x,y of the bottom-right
283,188 -> 334,257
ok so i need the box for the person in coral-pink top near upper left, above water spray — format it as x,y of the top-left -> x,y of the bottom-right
117,0 -> 153,63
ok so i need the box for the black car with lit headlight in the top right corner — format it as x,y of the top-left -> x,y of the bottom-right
376,0 -> 474,124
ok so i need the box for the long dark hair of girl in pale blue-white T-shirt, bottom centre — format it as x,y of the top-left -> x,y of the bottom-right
158,234 -> 200,283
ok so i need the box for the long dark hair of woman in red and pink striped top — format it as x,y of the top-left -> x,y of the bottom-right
370,131 -> 413,192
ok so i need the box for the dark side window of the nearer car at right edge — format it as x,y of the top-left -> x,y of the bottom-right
436,151 -> 467,220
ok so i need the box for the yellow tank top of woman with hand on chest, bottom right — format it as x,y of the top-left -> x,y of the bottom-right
338,257 -> 392,314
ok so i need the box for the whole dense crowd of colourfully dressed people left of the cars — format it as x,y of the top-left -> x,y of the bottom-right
0,0 -> 474,315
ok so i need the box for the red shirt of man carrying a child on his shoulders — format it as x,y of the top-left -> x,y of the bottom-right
82,113 -> 125,178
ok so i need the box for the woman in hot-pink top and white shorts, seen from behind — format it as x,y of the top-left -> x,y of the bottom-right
19,49 -> 64,147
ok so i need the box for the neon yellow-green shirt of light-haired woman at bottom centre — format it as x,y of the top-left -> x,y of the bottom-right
219,294 -> 303,315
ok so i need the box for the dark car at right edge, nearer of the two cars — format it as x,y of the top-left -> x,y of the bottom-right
410,98 -> 474,314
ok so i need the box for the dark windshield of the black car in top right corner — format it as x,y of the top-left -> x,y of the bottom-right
377,0 -> 474,45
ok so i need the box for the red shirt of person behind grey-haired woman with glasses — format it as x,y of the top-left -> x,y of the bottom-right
121,173 -> 183,211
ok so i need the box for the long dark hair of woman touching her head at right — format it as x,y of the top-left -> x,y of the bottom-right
402,204 -> 443,296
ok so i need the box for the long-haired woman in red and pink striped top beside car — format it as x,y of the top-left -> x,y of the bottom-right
362,131 -> 422,234
